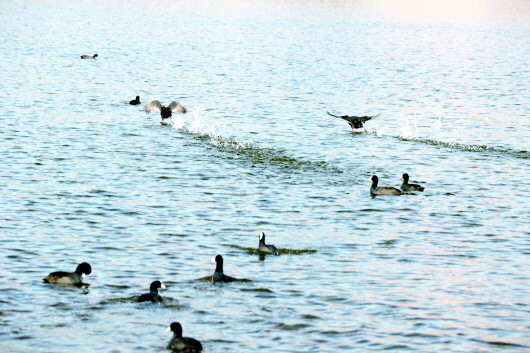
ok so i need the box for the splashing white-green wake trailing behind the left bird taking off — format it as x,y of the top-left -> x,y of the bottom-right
173,110 -> 342,173
